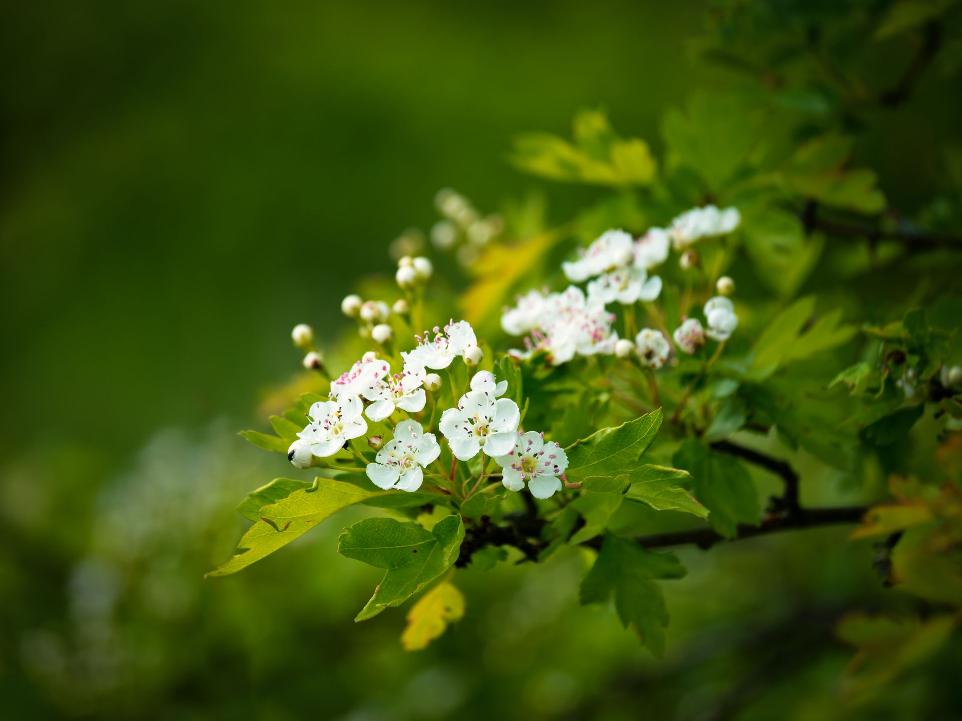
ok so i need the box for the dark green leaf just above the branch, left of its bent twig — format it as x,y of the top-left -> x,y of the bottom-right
672,438 -> 761,538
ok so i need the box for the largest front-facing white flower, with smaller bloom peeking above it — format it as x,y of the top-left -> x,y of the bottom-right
439,382 -> 521,461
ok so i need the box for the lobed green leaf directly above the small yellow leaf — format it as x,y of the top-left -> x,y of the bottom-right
337,515 -> 464,621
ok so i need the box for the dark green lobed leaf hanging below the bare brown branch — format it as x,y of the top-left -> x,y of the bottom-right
580,535 -> 685,657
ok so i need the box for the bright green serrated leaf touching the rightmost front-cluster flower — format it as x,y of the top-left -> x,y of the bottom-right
566,409 -> 662,481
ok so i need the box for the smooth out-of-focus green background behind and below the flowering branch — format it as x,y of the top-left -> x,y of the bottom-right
0,0 -> 957,720
